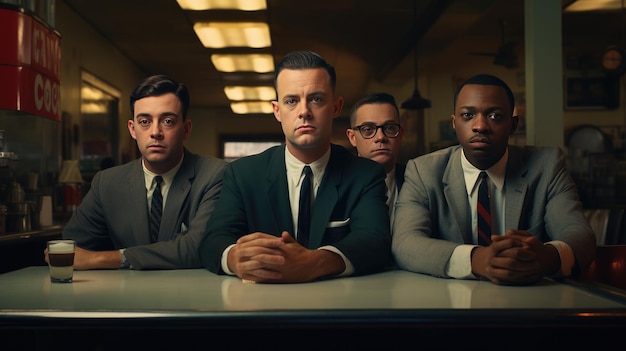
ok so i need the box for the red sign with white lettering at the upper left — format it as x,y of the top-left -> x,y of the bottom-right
0,8 -> 61,121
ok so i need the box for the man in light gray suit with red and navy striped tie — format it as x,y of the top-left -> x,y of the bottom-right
392,74 -> 595,285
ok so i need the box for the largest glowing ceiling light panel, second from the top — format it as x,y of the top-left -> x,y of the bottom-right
193,22 -> 272,48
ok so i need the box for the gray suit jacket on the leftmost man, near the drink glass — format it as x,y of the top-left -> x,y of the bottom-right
63,150 -> 226,269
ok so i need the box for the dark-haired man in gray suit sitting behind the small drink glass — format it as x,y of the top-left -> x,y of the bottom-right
46,75 -> 226,270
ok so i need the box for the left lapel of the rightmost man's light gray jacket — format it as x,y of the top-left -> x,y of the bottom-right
442,148 -> 472,243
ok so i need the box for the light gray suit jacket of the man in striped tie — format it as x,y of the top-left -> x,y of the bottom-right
392,145 -> 595,277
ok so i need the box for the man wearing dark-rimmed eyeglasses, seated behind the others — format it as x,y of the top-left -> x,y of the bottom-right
346,93 -> 406,223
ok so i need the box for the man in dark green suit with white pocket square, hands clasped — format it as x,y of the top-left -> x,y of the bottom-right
200,51 -> 391,283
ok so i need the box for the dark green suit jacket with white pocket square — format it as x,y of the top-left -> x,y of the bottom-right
200,144 -> 391,275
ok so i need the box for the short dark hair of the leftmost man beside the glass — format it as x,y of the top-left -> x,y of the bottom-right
130,74 -> 189,120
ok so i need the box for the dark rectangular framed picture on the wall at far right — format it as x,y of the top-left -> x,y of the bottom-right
564,76 -> 619,110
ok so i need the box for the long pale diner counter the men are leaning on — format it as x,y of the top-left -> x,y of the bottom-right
0,266 -> 626,346
